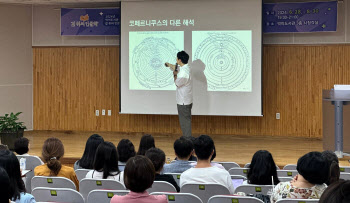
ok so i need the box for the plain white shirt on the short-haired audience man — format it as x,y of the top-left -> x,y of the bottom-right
180,166 -> 234,194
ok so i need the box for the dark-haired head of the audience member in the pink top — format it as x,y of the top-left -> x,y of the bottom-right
124,155 -> 155,193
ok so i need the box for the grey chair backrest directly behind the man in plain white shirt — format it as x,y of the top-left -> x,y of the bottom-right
180,184 -> 230,203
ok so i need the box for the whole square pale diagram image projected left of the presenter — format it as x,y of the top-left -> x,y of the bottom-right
129,32 -> 183,90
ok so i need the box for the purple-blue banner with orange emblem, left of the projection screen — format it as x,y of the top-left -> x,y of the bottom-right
61,8 -> 120,36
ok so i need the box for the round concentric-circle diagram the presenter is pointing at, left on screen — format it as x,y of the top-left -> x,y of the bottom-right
132,37 -> 178,89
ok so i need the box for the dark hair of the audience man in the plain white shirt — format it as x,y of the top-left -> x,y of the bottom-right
194,135 -> 214,160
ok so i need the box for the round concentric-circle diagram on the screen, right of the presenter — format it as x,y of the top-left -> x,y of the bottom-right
194,33 -> 251,91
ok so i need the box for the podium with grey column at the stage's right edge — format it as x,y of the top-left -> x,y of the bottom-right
322,90 -> 350,158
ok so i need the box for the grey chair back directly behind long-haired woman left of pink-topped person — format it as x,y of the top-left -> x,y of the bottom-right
79,178 -> 126,199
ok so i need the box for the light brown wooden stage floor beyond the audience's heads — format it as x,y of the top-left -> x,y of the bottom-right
24,131 -> 350,166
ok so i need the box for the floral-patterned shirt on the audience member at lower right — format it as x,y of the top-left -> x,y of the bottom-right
271,182 -> 327,203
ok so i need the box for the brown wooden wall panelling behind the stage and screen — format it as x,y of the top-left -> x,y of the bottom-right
33,45 -> 350,138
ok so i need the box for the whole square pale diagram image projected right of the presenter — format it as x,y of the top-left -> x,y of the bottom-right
192,31 -> 252,92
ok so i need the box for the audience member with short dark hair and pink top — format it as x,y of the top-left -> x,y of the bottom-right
111,156 -> 168,203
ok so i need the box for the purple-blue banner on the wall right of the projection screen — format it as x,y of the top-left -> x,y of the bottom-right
263,1 -> 337,33
